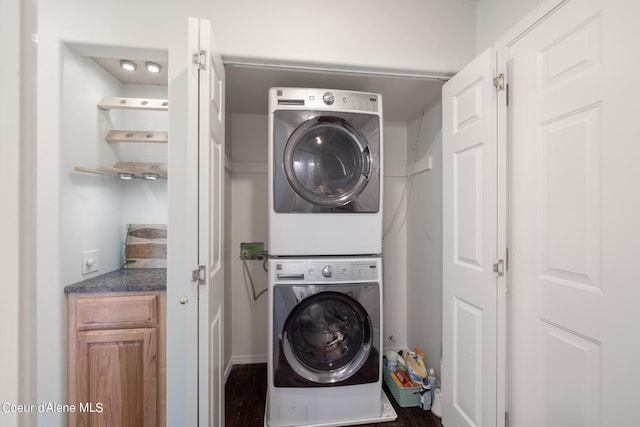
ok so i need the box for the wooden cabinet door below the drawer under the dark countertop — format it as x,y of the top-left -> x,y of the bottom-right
71,328 -> 158,427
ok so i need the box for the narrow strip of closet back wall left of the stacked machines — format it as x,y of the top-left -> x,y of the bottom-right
227,114 -> 268,363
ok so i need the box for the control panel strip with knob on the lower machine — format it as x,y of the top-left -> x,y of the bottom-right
271,258 -> 382,283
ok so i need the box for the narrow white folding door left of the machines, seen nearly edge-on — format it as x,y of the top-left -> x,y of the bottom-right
192,19 -> 225,427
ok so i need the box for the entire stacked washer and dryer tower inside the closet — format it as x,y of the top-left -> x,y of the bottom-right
266,88 -> 395,427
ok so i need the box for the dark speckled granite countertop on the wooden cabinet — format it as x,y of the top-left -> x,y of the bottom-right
64,268 -> 167,295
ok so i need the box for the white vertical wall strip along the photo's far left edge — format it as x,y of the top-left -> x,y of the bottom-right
0,0 -> 36,426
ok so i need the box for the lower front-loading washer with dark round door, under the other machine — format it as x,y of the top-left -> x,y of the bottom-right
267,257 -> 382,427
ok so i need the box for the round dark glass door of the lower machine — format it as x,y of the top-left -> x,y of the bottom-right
282,292 -> 373,384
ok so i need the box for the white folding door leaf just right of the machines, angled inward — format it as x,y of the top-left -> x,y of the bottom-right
442,49 -> 505,427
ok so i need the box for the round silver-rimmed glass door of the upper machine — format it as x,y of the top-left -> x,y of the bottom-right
284,116 -> 373,207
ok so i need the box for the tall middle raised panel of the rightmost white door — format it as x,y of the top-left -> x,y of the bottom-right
538,105 -> 602,290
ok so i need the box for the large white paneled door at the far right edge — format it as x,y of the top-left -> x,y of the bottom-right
507,0 -> 640,427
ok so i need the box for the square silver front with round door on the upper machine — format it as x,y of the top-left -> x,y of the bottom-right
273,110 -> 381,213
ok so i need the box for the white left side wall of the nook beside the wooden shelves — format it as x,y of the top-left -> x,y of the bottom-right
59,46 -> 123,288
